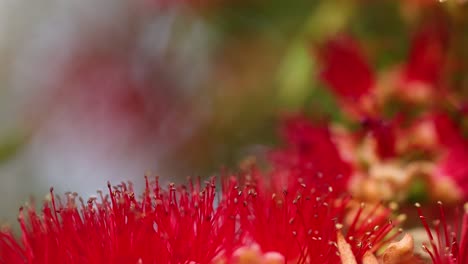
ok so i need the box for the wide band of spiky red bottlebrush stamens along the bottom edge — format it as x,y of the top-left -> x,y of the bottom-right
0,164 -> 414,264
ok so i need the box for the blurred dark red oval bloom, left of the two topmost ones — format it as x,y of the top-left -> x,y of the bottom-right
318,35 -> 375,103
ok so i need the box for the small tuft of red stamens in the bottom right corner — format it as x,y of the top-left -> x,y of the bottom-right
416,202 -> 468,264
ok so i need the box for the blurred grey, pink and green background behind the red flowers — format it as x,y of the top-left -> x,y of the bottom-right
0,0 -> 468,223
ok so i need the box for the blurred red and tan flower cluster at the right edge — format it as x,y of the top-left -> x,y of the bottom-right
317,16 -> 468,202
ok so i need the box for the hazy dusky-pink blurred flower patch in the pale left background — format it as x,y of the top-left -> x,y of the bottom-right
49,55 -> 183,139
